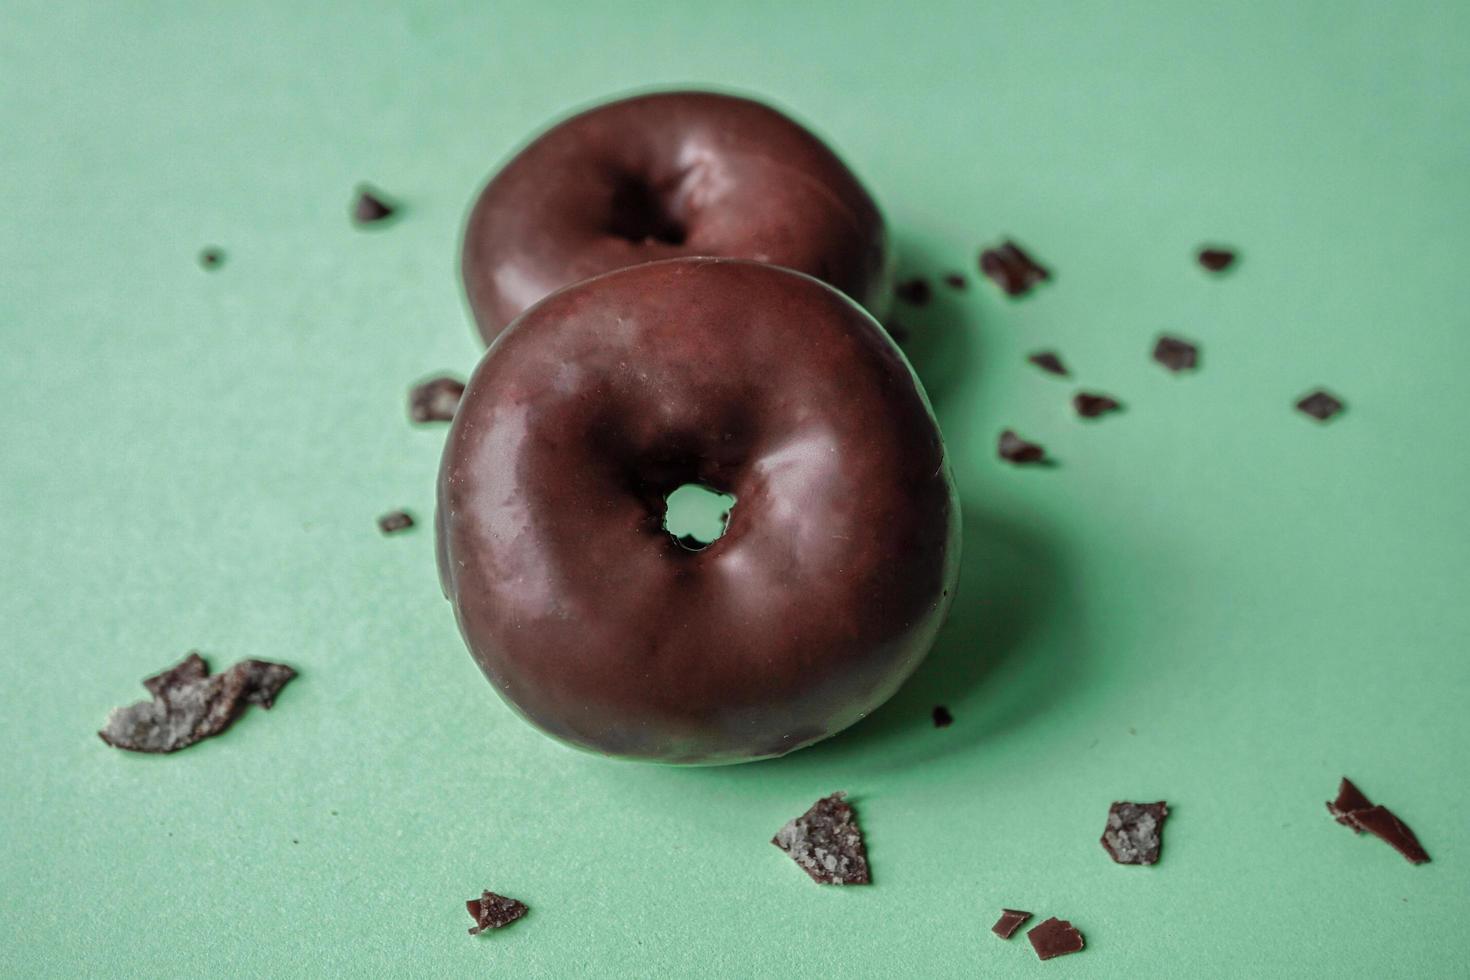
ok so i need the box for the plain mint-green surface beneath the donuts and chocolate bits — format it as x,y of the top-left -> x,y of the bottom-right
0,0 -> 1470,977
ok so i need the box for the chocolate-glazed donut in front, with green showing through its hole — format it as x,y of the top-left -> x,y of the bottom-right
435,259 -> 960,764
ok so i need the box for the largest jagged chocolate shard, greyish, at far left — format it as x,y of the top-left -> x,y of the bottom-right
97,652 -> 295,754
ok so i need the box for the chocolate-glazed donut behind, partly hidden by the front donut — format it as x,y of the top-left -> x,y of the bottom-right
463,93 -> 889,344
